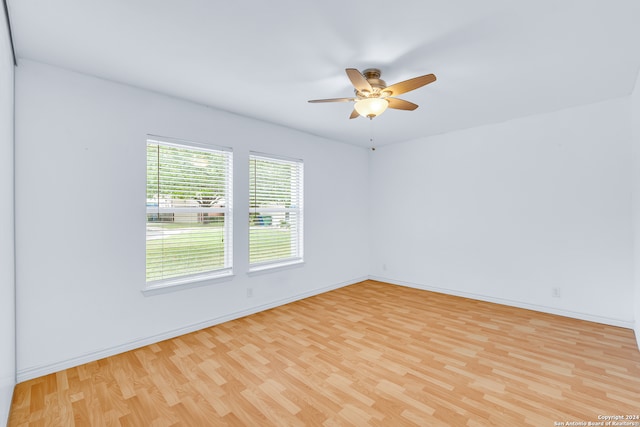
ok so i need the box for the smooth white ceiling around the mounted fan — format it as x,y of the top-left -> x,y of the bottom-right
7,0 -> 640,146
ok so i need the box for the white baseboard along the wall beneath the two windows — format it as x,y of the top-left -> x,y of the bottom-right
17,276 -> 368,383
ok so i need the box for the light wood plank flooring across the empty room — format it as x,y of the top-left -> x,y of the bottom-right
9,281 -> 640,427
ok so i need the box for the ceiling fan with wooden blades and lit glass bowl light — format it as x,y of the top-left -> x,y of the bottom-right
309,68 -> 436,119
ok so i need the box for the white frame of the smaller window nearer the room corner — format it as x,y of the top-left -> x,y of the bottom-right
247,151 -> 304,274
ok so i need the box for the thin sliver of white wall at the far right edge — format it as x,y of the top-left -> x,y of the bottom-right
631,74 -> 640,349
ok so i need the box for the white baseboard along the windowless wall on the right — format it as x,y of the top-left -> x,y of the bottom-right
369,276 -> 640,330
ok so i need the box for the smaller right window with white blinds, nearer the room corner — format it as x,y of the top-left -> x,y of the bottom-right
249,153 -> 303,271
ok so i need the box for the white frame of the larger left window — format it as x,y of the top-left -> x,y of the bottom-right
142,134 -> 234,295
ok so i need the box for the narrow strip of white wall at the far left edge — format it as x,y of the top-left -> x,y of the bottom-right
0,6 -> 16,425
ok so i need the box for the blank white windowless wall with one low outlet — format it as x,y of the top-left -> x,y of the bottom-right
370,98 -> 634,327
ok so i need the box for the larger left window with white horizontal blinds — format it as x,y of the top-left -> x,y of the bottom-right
146,138 -> 232,290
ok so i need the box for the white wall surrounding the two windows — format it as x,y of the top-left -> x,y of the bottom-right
15,61 -> 368,381
